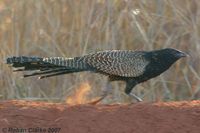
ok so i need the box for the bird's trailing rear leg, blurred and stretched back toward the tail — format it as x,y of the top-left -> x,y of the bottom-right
89,82 -> 112,105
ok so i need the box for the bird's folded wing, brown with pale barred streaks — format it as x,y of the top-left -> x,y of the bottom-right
86,50 -> 149,77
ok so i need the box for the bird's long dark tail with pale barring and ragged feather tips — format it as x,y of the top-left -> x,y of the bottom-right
6,56 -> 89,79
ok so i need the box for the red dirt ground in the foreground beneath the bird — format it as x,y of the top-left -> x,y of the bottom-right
0,100 -> 200,133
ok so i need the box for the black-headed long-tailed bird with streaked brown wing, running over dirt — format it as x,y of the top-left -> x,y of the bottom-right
6,48 -> 188,102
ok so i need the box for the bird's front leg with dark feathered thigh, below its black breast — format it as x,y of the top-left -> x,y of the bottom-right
125,80 -> 142,102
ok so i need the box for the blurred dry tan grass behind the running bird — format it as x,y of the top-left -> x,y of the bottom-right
0,0 -> 200,103
